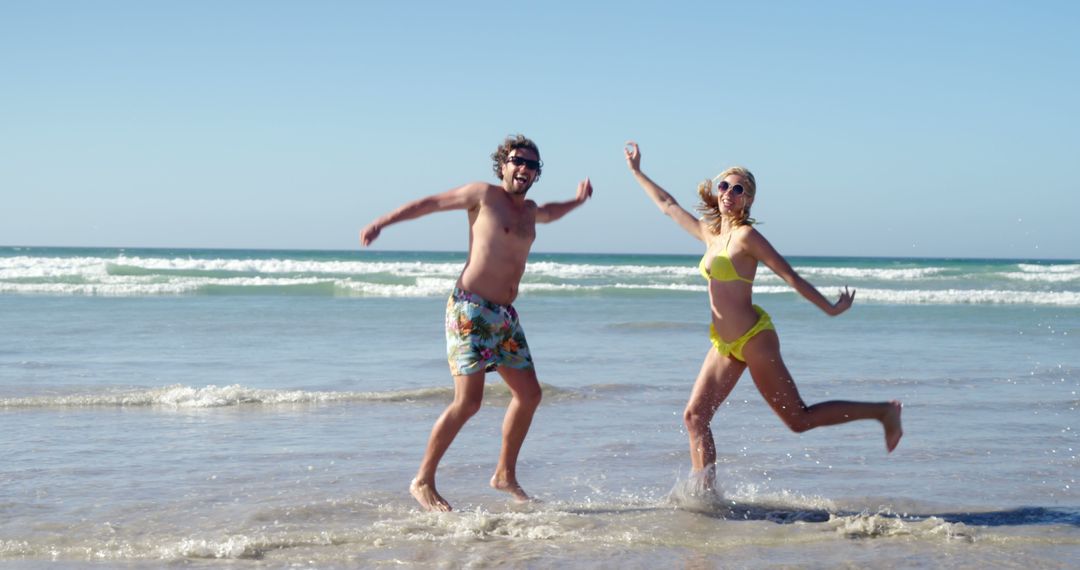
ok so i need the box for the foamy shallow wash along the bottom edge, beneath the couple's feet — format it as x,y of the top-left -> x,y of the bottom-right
0,503 -> 993,568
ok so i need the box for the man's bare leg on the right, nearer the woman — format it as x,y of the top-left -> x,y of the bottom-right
491,366 -> 541,501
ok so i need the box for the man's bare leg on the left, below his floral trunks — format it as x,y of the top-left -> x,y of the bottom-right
409,371 -> 484,511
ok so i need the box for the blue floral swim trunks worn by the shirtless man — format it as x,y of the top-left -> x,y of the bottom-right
446,287 -> 532,376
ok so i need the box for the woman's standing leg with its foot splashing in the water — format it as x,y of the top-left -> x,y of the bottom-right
683,349 -> 746,472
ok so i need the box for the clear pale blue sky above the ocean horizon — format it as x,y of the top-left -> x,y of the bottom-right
0,0 -> 1080,259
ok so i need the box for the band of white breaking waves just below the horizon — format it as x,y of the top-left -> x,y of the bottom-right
0,255 -> 1080,307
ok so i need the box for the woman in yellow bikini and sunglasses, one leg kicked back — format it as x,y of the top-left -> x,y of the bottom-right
624,141 -> 903,483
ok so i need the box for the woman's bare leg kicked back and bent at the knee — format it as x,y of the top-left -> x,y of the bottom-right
743,330 -> 904,451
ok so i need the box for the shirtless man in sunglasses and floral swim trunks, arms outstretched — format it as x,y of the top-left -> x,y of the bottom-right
360,135 -> 593,511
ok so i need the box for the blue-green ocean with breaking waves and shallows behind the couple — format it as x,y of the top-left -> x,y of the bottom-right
0,247 -> 1080,569
